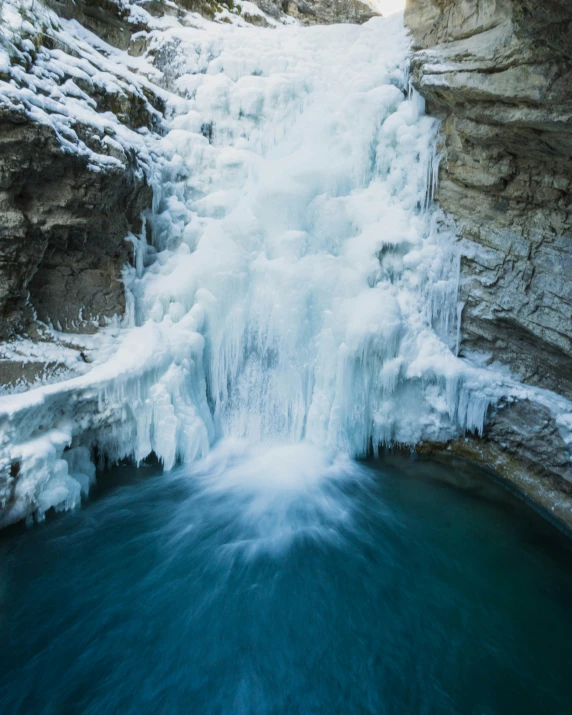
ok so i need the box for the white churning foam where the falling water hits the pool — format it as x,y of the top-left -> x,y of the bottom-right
167,439 -> 372,565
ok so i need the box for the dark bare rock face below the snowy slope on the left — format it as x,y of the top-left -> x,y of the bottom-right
0,112 -> 151,337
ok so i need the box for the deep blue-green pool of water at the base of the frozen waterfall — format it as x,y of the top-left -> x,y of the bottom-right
0,444 -> 572,715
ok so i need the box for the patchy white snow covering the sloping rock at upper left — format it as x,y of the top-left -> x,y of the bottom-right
0,0 -> 167,176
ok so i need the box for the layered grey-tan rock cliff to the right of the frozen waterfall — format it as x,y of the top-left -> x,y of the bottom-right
405,0 -> 572,510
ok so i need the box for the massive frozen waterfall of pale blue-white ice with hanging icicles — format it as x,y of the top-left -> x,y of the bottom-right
0,1 -> 564,520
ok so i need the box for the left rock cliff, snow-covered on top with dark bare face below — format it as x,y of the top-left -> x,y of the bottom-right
0,2 -> 162,388
